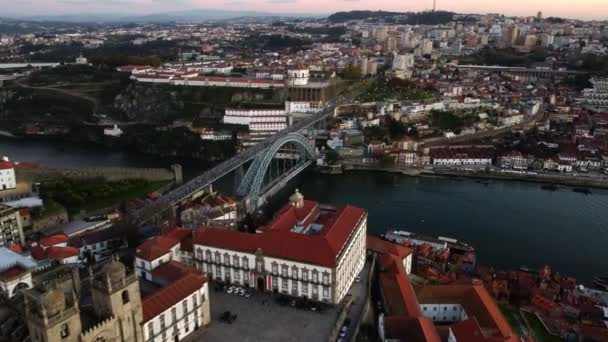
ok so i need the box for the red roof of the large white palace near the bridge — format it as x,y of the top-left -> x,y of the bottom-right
194,201 -> 366,267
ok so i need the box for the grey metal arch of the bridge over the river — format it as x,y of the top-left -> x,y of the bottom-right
237,133 -> 317,200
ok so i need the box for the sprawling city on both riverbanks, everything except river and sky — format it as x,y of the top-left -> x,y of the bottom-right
0,6 -> 608,342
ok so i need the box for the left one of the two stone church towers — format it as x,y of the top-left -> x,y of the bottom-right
24,285 -> 82,342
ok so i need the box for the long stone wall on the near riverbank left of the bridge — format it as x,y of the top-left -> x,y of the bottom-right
15,167 -> 181,182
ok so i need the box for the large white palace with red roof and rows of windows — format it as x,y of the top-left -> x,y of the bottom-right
194,190 -> 367,304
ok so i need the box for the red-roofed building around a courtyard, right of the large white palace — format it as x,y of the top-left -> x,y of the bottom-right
368,239 -> 519,342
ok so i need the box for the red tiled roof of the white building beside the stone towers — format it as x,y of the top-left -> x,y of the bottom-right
142,273 -> 207,322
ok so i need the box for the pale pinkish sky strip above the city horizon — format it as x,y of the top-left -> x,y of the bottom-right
0,0 -> 608,20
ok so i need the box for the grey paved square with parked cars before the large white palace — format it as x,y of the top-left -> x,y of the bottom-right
190,285 -> 338,342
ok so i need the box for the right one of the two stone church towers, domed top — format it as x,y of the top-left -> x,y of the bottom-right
91,258 -> 143,342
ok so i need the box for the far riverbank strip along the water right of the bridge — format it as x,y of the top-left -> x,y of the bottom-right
334,163 -> 608,189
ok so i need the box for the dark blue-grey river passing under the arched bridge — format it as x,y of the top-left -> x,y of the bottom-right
0,137 -> 608,283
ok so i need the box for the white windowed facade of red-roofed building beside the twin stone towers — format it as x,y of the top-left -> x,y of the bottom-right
143,282 -> 209,342
